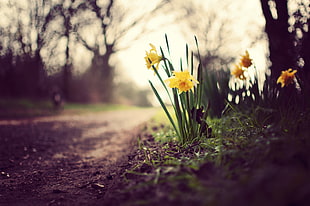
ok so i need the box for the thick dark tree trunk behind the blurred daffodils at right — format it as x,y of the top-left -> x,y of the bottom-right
261,0 -> 310,80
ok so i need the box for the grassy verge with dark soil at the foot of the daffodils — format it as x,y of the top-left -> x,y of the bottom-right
114,104 -> 310,206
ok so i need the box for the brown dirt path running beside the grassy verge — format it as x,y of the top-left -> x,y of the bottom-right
0,109 -> 157,205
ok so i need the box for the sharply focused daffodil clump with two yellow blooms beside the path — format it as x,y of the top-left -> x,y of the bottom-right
144,36 -> 211,144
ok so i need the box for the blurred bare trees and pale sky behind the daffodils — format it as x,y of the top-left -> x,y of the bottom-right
0,0 -> 310,110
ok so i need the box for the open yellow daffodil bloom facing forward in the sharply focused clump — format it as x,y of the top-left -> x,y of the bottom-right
165,71 -> 199,93
